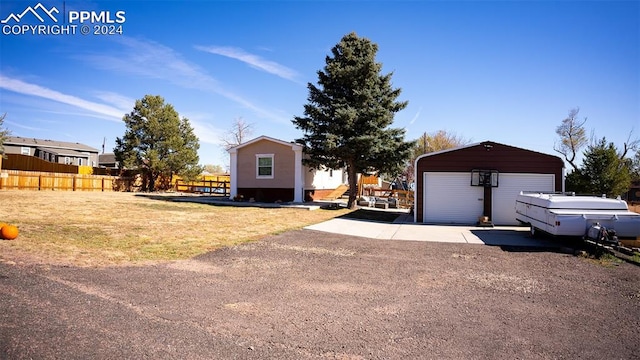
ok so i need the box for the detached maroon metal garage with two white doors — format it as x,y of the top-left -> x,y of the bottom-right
414,141 -> 564,225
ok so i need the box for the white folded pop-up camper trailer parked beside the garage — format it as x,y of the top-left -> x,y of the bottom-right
516,192 -> 640,238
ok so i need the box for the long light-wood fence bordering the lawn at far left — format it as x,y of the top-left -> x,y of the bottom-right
0,170 -> 120,191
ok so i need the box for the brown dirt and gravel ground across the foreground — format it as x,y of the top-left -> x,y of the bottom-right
0,230 -> 640,359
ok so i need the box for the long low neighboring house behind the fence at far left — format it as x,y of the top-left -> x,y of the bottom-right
4,136 -> 98,166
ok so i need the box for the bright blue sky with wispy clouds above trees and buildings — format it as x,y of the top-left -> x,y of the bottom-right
0,0 -> 640,166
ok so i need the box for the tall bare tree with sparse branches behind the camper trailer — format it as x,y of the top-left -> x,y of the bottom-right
553,107 -> 588,170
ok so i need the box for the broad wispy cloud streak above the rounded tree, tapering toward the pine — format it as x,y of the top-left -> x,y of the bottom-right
79,37 -> 289,122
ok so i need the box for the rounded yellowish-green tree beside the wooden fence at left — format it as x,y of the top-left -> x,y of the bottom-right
114,95 -> 202,191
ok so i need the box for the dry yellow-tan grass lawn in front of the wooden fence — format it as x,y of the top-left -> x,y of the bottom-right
0,191 -> 348,266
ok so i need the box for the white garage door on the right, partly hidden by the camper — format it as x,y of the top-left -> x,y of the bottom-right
491,173 -> 555,225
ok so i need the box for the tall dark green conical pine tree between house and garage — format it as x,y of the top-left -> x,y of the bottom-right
293,33 -> 413,208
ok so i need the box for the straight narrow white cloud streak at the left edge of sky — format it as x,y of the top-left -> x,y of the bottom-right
0,75 -> 124,122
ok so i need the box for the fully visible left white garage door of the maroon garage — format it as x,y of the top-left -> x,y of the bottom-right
423,172 -> 482,224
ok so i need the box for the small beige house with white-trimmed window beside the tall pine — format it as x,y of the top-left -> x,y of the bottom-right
229,136 -> 345,202
